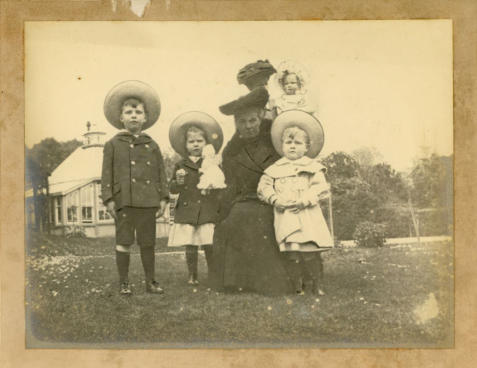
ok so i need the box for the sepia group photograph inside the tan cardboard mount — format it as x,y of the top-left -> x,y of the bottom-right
24,19 -> 454,349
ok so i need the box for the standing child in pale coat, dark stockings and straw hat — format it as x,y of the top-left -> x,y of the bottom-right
257,111 -> 334,295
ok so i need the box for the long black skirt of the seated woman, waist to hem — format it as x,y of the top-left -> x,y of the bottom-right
209,200 -> 292,295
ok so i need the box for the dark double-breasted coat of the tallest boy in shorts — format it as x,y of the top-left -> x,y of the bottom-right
101,132 -> 169,210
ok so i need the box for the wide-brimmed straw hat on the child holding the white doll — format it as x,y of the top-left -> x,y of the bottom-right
169,111 -> 224,157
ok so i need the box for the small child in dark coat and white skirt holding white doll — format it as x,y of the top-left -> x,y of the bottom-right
168,111 -> 224,285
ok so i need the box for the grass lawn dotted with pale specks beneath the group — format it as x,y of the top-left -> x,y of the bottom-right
26,235 -> 453,348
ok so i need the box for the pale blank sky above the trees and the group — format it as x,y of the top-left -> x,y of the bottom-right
25,20 -> 453,170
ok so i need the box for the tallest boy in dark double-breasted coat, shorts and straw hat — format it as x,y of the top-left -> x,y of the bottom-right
101,81 -> 168,295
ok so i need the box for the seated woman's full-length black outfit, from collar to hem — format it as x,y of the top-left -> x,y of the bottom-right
209,121 -> 292,295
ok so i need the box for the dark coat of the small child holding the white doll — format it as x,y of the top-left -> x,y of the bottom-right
170,158 -> 219,225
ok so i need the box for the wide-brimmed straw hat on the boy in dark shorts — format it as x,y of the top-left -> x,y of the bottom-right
104,80 -> 161,130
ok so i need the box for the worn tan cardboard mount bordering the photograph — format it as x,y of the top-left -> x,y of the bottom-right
0,0 -> 477,367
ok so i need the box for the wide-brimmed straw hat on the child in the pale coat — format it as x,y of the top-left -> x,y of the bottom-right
271,110 -> 325,158
